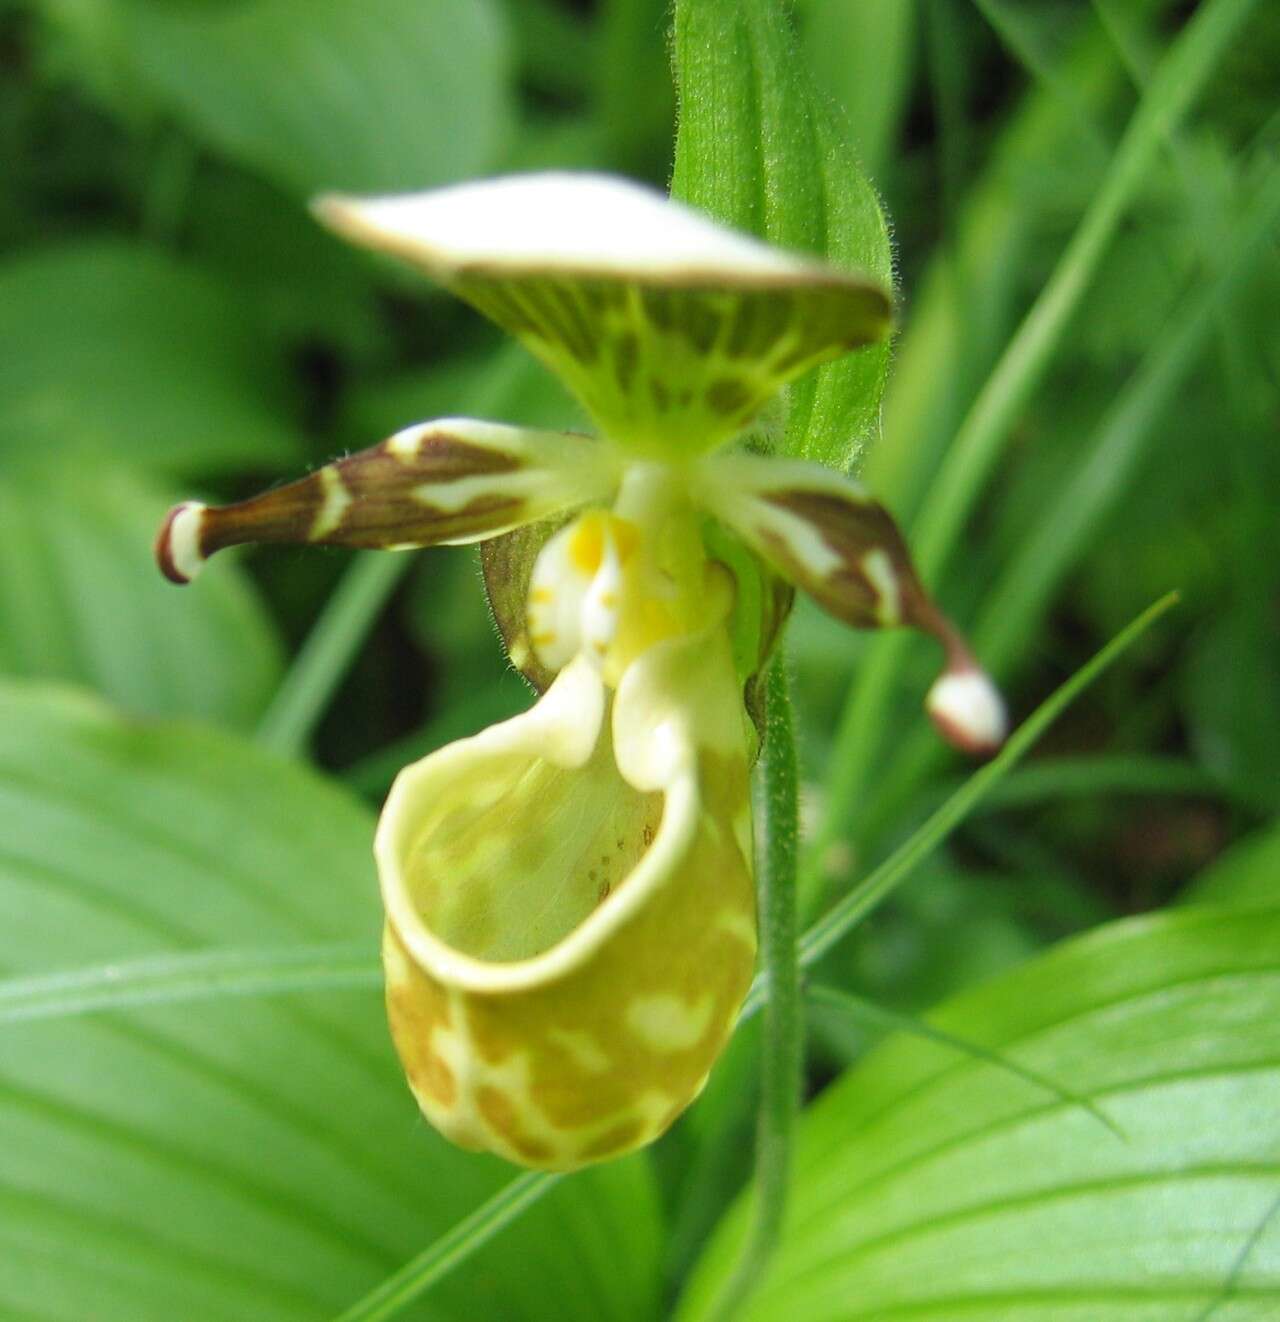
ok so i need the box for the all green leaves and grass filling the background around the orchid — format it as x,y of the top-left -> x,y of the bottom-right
0,0 -> 1280,1322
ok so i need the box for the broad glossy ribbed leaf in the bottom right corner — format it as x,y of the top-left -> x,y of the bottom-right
680,908 -> 1280,1322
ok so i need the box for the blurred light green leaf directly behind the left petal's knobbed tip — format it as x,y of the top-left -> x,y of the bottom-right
0,459 -> 282,726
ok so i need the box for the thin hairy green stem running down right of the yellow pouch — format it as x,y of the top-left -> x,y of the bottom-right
711,656 -> 804,1322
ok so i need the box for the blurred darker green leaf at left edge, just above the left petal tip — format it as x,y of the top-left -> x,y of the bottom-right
0,239 -> 300,473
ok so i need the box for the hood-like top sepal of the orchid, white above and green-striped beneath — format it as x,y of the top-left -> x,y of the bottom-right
316,175 -> 891,457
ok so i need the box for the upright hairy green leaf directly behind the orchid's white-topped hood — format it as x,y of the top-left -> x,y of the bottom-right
672,0 -> 893,468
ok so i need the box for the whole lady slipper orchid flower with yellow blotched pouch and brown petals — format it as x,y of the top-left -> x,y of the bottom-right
157,175 -> 1004,1169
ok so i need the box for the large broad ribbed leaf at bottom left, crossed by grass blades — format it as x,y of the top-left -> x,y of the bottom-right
0,685 -> 657,1322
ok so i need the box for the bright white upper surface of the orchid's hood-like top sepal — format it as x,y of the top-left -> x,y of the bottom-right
312,172 -> 838,283
